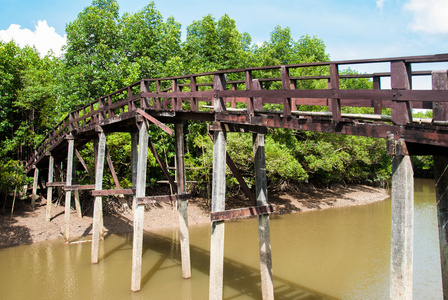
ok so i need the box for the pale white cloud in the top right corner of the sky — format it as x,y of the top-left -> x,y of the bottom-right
404,0 -> 448,34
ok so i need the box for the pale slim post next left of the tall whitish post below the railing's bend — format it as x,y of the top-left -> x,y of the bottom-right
90,131 -> 106,264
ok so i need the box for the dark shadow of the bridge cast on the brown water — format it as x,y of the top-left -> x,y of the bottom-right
100,212 -> 336,300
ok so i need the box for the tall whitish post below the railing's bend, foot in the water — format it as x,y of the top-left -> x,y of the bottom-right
131,122 -> 148,292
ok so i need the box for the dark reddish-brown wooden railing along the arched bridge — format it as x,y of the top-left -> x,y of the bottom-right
27,54 -> 448,170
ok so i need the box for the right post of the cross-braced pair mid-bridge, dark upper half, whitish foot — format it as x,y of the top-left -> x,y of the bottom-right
253,133 -> 274,299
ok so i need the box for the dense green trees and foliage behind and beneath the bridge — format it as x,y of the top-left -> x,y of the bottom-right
0,0 -> 428,197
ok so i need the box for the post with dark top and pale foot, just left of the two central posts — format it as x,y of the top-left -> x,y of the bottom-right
175,124 -> 191,278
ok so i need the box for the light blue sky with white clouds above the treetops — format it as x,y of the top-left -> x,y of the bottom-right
0,0 -> 448,81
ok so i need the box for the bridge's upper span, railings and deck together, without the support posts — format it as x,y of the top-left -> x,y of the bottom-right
26,54 -> 448,171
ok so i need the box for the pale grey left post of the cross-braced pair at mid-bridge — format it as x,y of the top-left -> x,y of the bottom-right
209,123 -> 227,300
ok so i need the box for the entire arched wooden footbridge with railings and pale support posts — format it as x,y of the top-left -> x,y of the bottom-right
26,54 -> 448,299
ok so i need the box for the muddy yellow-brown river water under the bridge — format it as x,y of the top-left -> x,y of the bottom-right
0,180 -> 442,300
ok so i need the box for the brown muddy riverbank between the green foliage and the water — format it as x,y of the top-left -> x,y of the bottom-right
0,185 -> 389,248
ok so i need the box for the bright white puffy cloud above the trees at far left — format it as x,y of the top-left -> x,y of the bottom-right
0,20 -> 67,56
